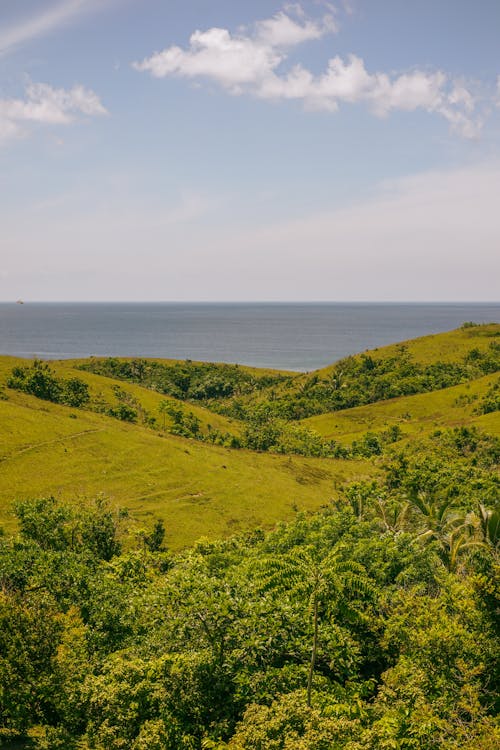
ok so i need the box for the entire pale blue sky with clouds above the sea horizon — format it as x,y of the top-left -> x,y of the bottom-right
0,0 -> 500,301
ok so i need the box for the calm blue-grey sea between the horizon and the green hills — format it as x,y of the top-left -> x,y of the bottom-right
0,303 -> 500,371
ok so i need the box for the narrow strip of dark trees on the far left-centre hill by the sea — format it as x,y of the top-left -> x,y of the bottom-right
80,357 -> 290,401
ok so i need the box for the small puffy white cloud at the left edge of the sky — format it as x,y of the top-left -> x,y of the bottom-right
0,83 -> 106,143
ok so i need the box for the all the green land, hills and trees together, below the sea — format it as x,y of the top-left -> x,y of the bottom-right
0,325 -> 500,750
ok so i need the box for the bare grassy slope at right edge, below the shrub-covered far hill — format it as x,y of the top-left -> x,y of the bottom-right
302,373 -> 500,444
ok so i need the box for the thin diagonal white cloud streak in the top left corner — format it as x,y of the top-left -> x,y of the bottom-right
0,0 -> 109,56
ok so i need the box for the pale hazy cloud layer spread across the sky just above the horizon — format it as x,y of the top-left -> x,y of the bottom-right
4,163 -> 500,301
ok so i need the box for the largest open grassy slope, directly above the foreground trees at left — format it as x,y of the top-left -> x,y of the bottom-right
0,391 -> 376,548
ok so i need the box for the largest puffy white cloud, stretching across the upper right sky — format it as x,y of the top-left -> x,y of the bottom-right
133,6 -> 482,138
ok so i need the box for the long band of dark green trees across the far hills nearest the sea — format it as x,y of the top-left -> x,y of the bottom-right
75,340 -> 500,434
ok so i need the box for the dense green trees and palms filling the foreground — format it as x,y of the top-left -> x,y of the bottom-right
0,429 -> 500,750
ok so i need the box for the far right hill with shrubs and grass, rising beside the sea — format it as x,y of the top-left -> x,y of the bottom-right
208,323 -> 500,420
